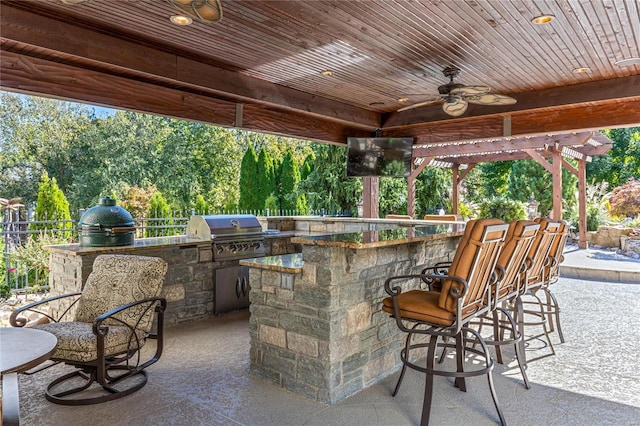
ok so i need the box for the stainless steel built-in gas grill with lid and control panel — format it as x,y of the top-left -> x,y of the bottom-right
187,214 -> 265,261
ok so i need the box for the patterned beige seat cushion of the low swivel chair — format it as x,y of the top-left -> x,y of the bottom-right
33,322 -> 145,362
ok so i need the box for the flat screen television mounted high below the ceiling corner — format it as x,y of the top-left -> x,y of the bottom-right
347,138 -> 413,177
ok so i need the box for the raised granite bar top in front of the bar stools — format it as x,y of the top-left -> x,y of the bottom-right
291,224 -> 465,249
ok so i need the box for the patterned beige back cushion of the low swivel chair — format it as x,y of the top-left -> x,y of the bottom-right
75,255 -> 167,331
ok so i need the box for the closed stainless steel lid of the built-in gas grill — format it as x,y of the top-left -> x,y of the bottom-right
187,214 -> 262,240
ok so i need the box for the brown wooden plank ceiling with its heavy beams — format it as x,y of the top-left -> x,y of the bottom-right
0,0 -> 640,158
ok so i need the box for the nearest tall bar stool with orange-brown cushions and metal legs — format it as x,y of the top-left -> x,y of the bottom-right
382,219 -> 508,425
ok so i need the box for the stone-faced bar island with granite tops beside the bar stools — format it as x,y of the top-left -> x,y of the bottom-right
240,224 -> 464,404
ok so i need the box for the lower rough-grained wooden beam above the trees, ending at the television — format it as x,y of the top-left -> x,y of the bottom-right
0,50 -> 370,144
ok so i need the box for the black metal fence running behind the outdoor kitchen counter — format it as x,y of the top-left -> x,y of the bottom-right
0,209 -> 350,299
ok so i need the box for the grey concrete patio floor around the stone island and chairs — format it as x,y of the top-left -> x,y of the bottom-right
8,278 -> 640,426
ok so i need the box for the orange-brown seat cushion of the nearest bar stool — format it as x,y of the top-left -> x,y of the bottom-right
382,290 -> 454,325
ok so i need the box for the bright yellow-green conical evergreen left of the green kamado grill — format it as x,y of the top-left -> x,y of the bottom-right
31,171 -> 73,238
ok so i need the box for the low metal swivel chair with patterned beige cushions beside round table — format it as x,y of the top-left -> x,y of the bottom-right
10,255 -> 167,405
